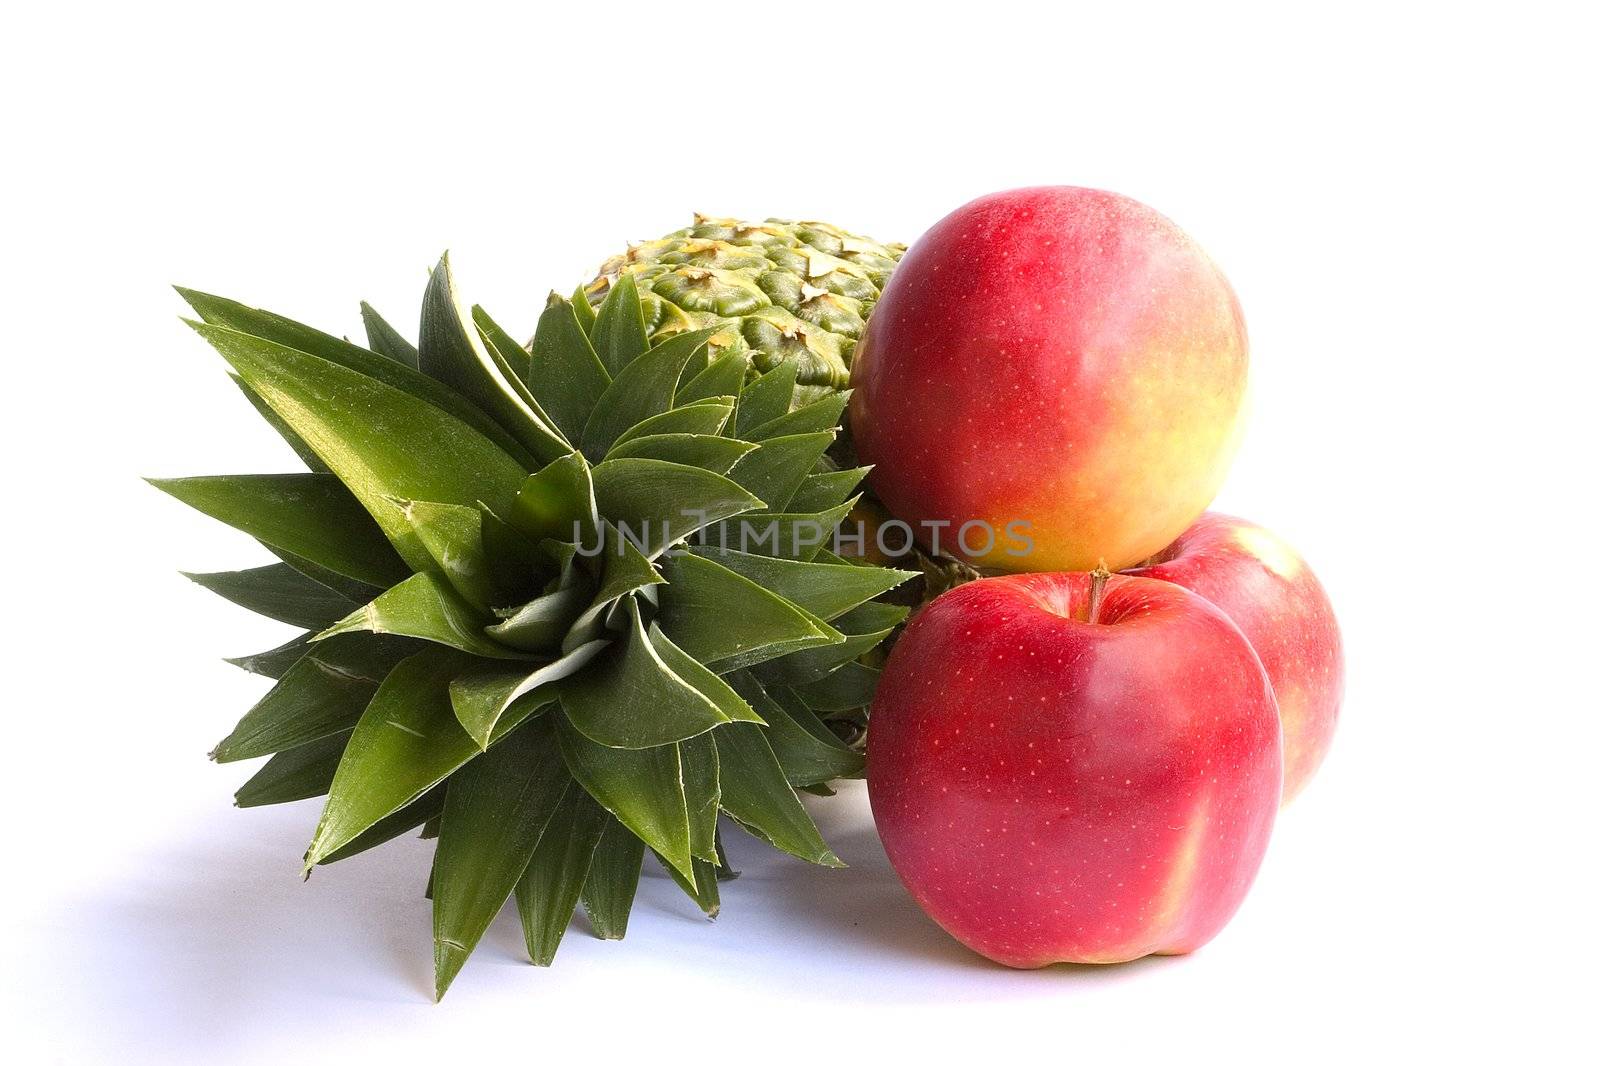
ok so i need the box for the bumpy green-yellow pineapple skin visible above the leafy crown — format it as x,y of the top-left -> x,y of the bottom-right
584,214 -> 906,394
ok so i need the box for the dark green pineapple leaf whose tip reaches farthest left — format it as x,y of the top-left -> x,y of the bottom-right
150,474 -> 410,586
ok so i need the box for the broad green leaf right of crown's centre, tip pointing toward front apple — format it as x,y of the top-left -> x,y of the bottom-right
656,554 -> 843,672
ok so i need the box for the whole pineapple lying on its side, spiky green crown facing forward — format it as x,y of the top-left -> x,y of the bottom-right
154,249 -> 910,996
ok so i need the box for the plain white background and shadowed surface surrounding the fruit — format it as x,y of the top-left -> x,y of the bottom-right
0,0 -> 1600,1064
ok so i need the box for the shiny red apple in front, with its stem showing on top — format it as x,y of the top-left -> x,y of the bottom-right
867,573 -> 1283,968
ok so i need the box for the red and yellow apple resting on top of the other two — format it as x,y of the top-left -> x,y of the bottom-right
850,186 -> 1250,571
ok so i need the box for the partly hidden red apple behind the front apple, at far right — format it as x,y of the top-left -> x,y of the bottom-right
1128,512 -> 1344,804
